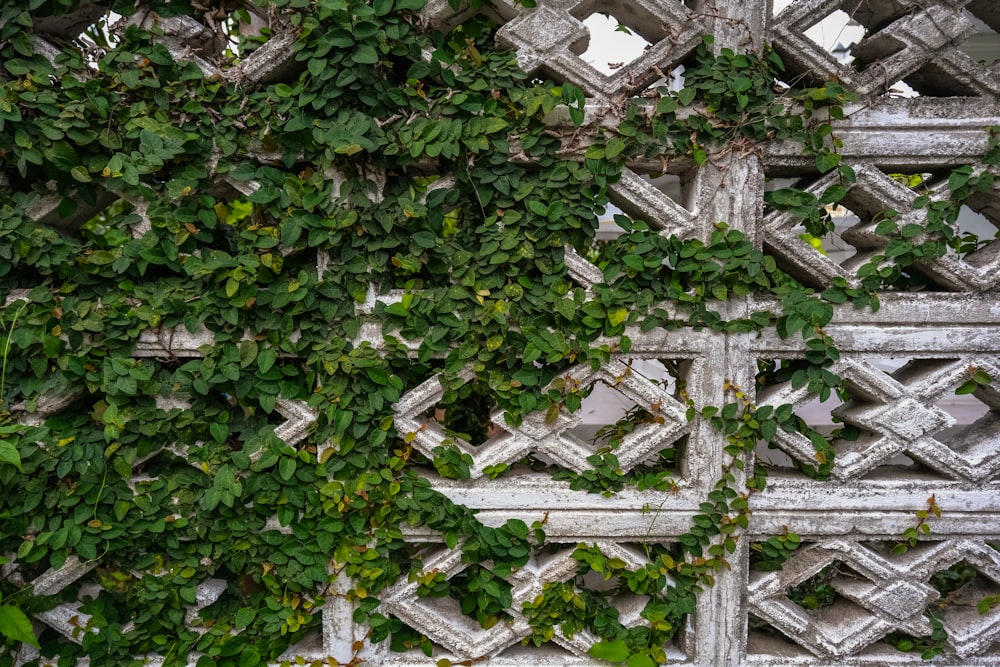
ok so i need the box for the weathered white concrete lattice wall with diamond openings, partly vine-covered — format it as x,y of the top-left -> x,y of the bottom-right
1,0 -> 1000,667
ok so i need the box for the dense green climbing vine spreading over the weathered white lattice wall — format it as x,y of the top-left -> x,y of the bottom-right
0,0 -> 1000,667
